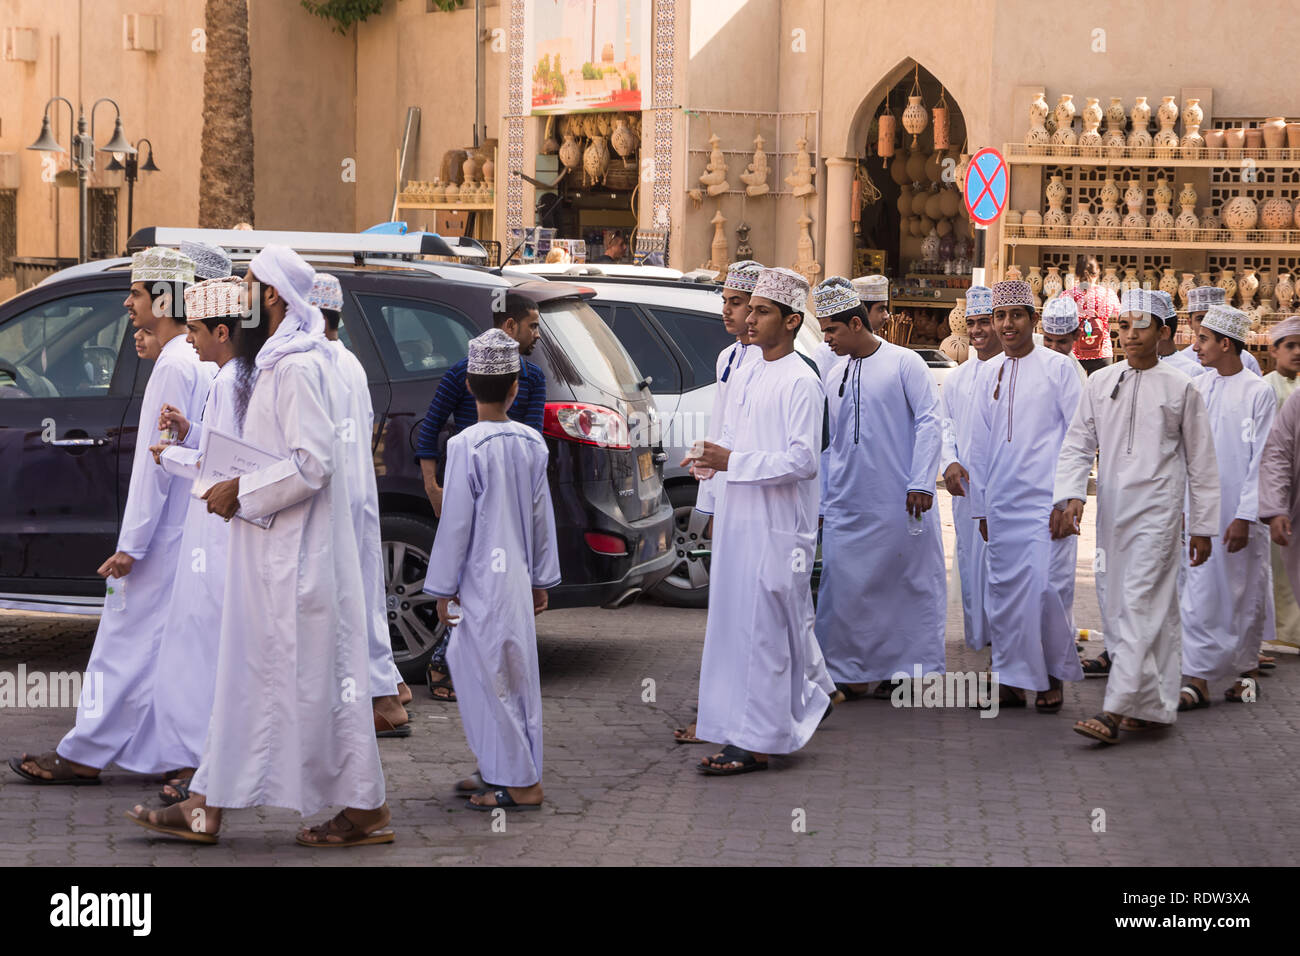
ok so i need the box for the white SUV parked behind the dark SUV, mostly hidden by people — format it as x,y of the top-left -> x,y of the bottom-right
503,265 -> 822,607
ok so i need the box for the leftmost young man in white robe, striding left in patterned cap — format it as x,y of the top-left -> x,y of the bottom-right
9,247 -> 216,784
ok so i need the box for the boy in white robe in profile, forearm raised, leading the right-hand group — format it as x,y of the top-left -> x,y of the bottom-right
697,269 -> 831,775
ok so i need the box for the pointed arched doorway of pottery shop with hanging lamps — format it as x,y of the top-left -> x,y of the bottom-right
850,57 -> 974,347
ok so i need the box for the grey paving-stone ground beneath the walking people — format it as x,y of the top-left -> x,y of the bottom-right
0,494 -> 1300,866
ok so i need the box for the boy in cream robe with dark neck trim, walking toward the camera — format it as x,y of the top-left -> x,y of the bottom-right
1050,302 -> 1219,744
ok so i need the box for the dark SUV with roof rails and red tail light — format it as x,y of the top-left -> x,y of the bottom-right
0,229 -> 675,678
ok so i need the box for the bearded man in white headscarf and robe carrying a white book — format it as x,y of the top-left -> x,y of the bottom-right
127,246 -> 394,847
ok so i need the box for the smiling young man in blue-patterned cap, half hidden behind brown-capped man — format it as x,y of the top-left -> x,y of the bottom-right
939,285 -> 1002,650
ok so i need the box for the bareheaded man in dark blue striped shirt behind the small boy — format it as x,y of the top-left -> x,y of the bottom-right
415,293 -> 546,704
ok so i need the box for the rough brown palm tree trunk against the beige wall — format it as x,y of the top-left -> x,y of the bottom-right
199,0 -> 254,229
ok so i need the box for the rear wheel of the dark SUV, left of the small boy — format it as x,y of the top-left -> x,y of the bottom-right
380,515 -> 446,684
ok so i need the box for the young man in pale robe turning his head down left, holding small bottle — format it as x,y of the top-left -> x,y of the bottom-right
813,276 -> 948,700
